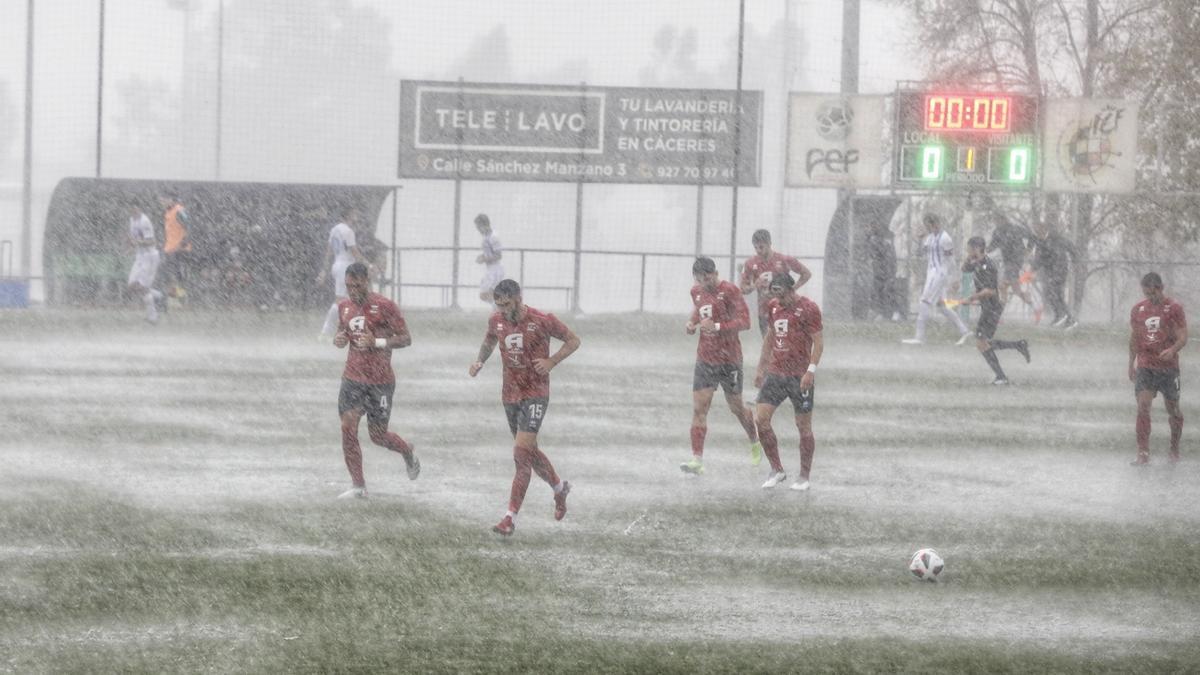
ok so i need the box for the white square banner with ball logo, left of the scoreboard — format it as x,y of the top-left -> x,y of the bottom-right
786,94 -> 886,189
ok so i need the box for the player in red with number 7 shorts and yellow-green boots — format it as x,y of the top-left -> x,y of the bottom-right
679,258 -> 762,474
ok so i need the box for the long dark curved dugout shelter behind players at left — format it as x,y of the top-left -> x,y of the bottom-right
42,178 -> 395,309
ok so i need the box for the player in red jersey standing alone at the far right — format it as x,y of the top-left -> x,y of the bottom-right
1129,271 -> 1188,466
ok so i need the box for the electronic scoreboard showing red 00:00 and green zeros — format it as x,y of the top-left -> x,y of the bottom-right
892,90 -> 1038,190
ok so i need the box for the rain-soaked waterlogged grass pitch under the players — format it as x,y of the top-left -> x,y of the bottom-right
0,310 -> 1200,673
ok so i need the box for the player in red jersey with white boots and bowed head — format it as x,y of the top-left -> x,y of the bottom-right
755,274 -> 824,490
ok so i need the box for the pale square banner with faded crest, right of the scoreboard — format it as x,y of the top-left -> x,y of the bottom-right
1042,98 -> 1138,193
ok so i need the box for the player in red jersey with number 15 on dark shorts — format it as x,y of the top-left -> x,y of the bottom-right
467,279 -> 580,536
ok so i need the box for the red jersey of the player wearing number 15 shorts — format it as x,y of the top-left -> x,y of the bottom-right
487,306 -> 568,404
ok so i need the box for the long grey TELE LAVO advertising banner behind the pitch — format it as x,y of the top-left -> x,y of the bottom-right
398,80 -> 762,186
